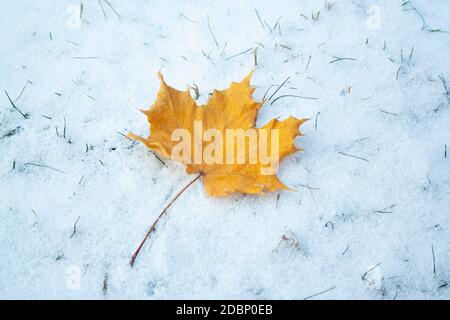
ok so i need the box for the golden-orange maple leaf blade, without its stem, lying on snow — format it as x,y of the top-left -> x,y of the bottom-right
129,71 -> 308,196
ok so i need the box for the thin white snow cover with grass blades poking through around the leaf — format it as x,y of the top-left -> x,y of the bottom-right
0,0 -> 450,299
